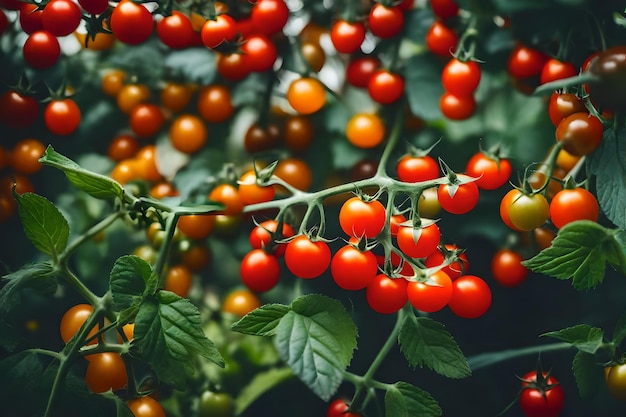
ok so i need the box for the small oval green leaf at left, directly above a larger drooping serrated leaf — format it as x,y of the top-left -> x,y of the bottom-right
109,255 -> 152,311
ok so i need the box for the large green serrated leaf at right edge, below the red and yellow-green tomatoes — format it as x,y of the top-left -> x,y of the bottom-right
522,220 -> 624,291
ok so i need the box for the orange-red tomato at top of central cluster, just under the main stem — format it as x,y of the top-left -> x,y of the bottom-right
339,196 -> 386,238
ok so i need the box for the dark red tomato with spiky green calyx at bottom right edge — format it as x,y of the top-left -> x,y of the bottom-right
519,371 -> 565,417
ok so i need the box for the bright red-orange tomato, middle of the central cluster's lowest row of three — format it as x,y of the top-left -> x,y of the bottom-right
407,270 -> 452,313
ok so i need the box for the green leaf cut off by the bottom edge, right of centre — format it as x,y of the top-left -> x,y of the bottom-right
385,381 -> 442,417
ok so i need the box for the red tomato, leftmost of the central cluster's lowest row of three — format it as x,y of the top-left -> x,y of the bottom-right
365,274 -> 409,314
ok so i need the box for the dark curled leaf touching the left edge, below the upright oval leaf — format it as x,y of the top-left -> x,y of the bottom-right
0,262 -> 57,315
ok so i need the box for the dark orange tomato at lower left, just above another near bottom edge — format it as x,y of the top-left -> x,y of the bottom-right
85,352 -> 128,394
